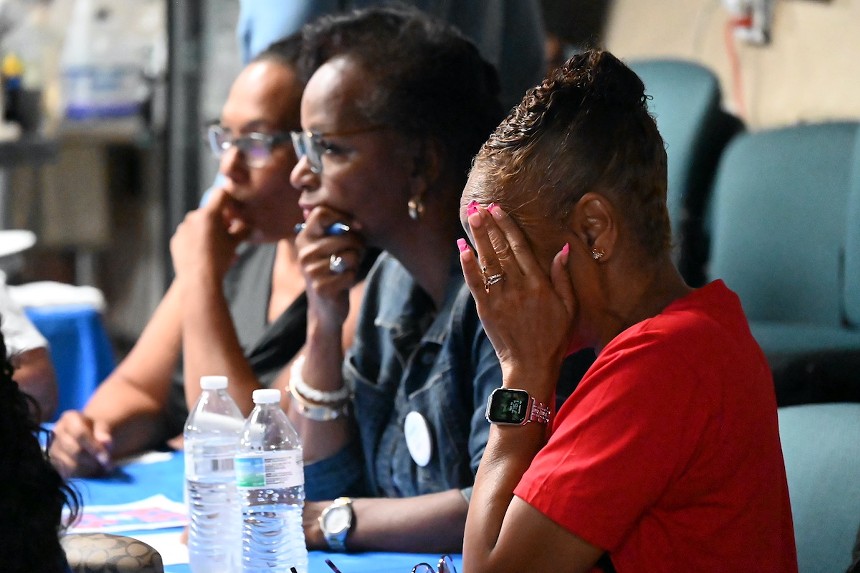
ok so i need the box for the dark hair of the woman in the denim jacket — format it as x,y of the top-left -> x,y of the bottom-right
300,5 -> 504,182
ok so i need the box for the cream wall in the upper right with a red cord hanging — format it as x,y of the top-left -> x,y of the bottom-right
605,0 -> 860,129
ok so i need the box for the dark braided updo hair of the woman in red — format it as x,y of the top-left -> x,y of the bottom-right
470,49 -> 671,255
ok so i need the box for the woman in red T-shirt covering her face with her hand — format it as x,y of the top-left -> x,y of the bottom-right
461,50 -> 797,573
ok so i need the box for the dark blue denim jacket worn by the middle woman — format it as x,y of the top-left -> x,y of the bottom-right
305,253 -> 502,498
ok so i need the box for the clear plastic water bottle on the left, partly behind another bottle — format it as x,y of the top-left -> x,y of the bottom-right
184,376 -> 244,573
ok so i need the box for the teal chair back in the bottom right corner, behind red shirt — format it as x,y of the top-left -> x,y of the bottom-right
779,403 -> 860,573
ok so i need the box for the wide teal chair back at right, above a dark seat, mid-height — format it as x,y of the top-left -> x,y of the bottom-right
709,122 -> 860,326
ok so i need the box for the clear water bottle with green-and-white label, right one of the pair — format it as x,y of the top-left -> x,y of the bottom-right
236,389 -> 308,573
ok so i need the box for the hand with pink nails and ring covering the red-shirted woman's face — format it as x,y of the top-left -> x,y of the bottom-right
459,204 -> 576,390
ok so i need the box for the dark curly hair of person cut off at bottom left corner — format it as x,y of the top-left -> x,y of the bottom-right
0,317 -> 81,573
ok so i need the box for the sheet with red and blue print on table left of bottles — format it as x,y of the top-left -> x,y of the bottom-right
69,494 -> 188,533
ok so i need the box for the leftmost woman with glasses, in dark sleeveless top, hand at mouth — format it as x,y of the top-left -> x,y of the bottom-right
52,36 -> 368,494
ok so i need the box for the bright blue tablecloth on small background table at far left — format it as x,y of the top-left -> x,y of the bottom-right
25,305 -> 116,421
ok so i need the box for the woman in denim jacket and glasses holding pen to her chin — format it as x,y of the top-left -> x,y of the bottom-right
290,8 -> 502,552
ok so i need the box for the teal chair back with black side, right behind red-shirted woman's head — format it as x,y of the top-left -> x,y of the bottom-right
629,59 -> 742,285
